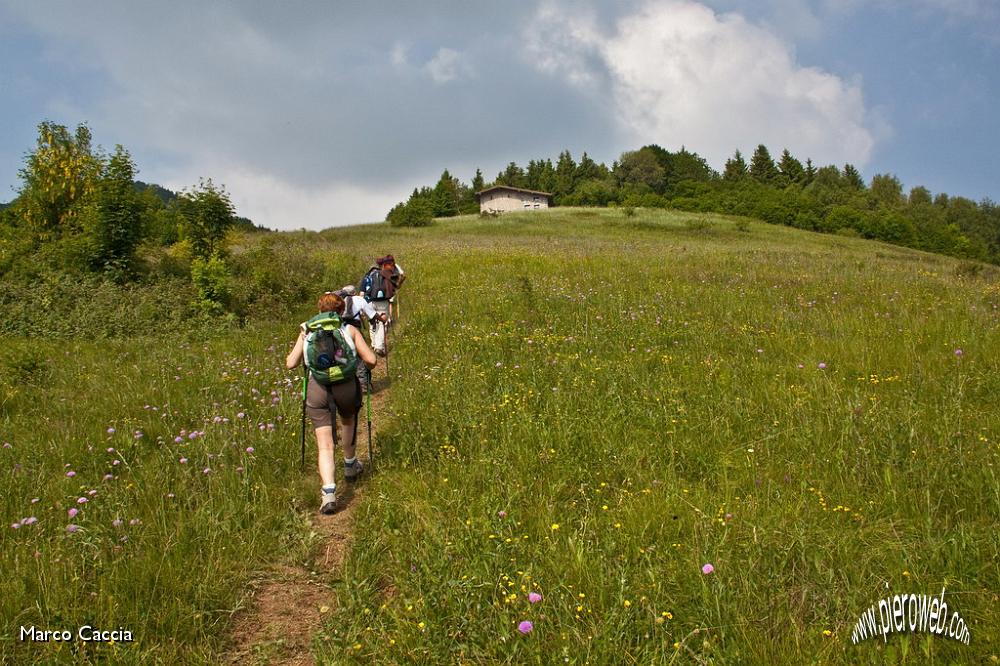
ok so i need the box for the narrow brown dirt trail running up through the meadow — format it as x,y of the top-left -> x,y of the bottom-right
225,362 -> 389,666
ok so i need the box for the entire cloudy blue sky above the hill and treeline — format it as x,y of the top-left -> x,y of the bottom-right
0,0 -> 1000,229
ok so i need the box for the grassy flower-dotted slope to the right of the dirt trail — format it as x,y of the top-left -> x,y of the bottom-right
317,210 -> 1000,664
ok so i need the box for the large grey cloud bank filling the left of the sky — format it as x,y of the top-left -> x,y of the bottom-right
0,0 -> 613,227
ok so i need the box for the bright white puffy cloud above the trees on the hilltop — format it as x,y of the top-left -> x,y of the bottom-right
526,0 -> 875,167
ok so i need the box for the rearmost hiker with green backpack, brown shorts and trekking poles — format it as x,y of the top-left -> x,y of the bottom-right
285,291 -> 376,514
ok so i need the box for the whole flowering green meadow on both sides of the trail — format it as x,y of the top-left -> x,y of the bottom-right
0,209 -> 1000,664
